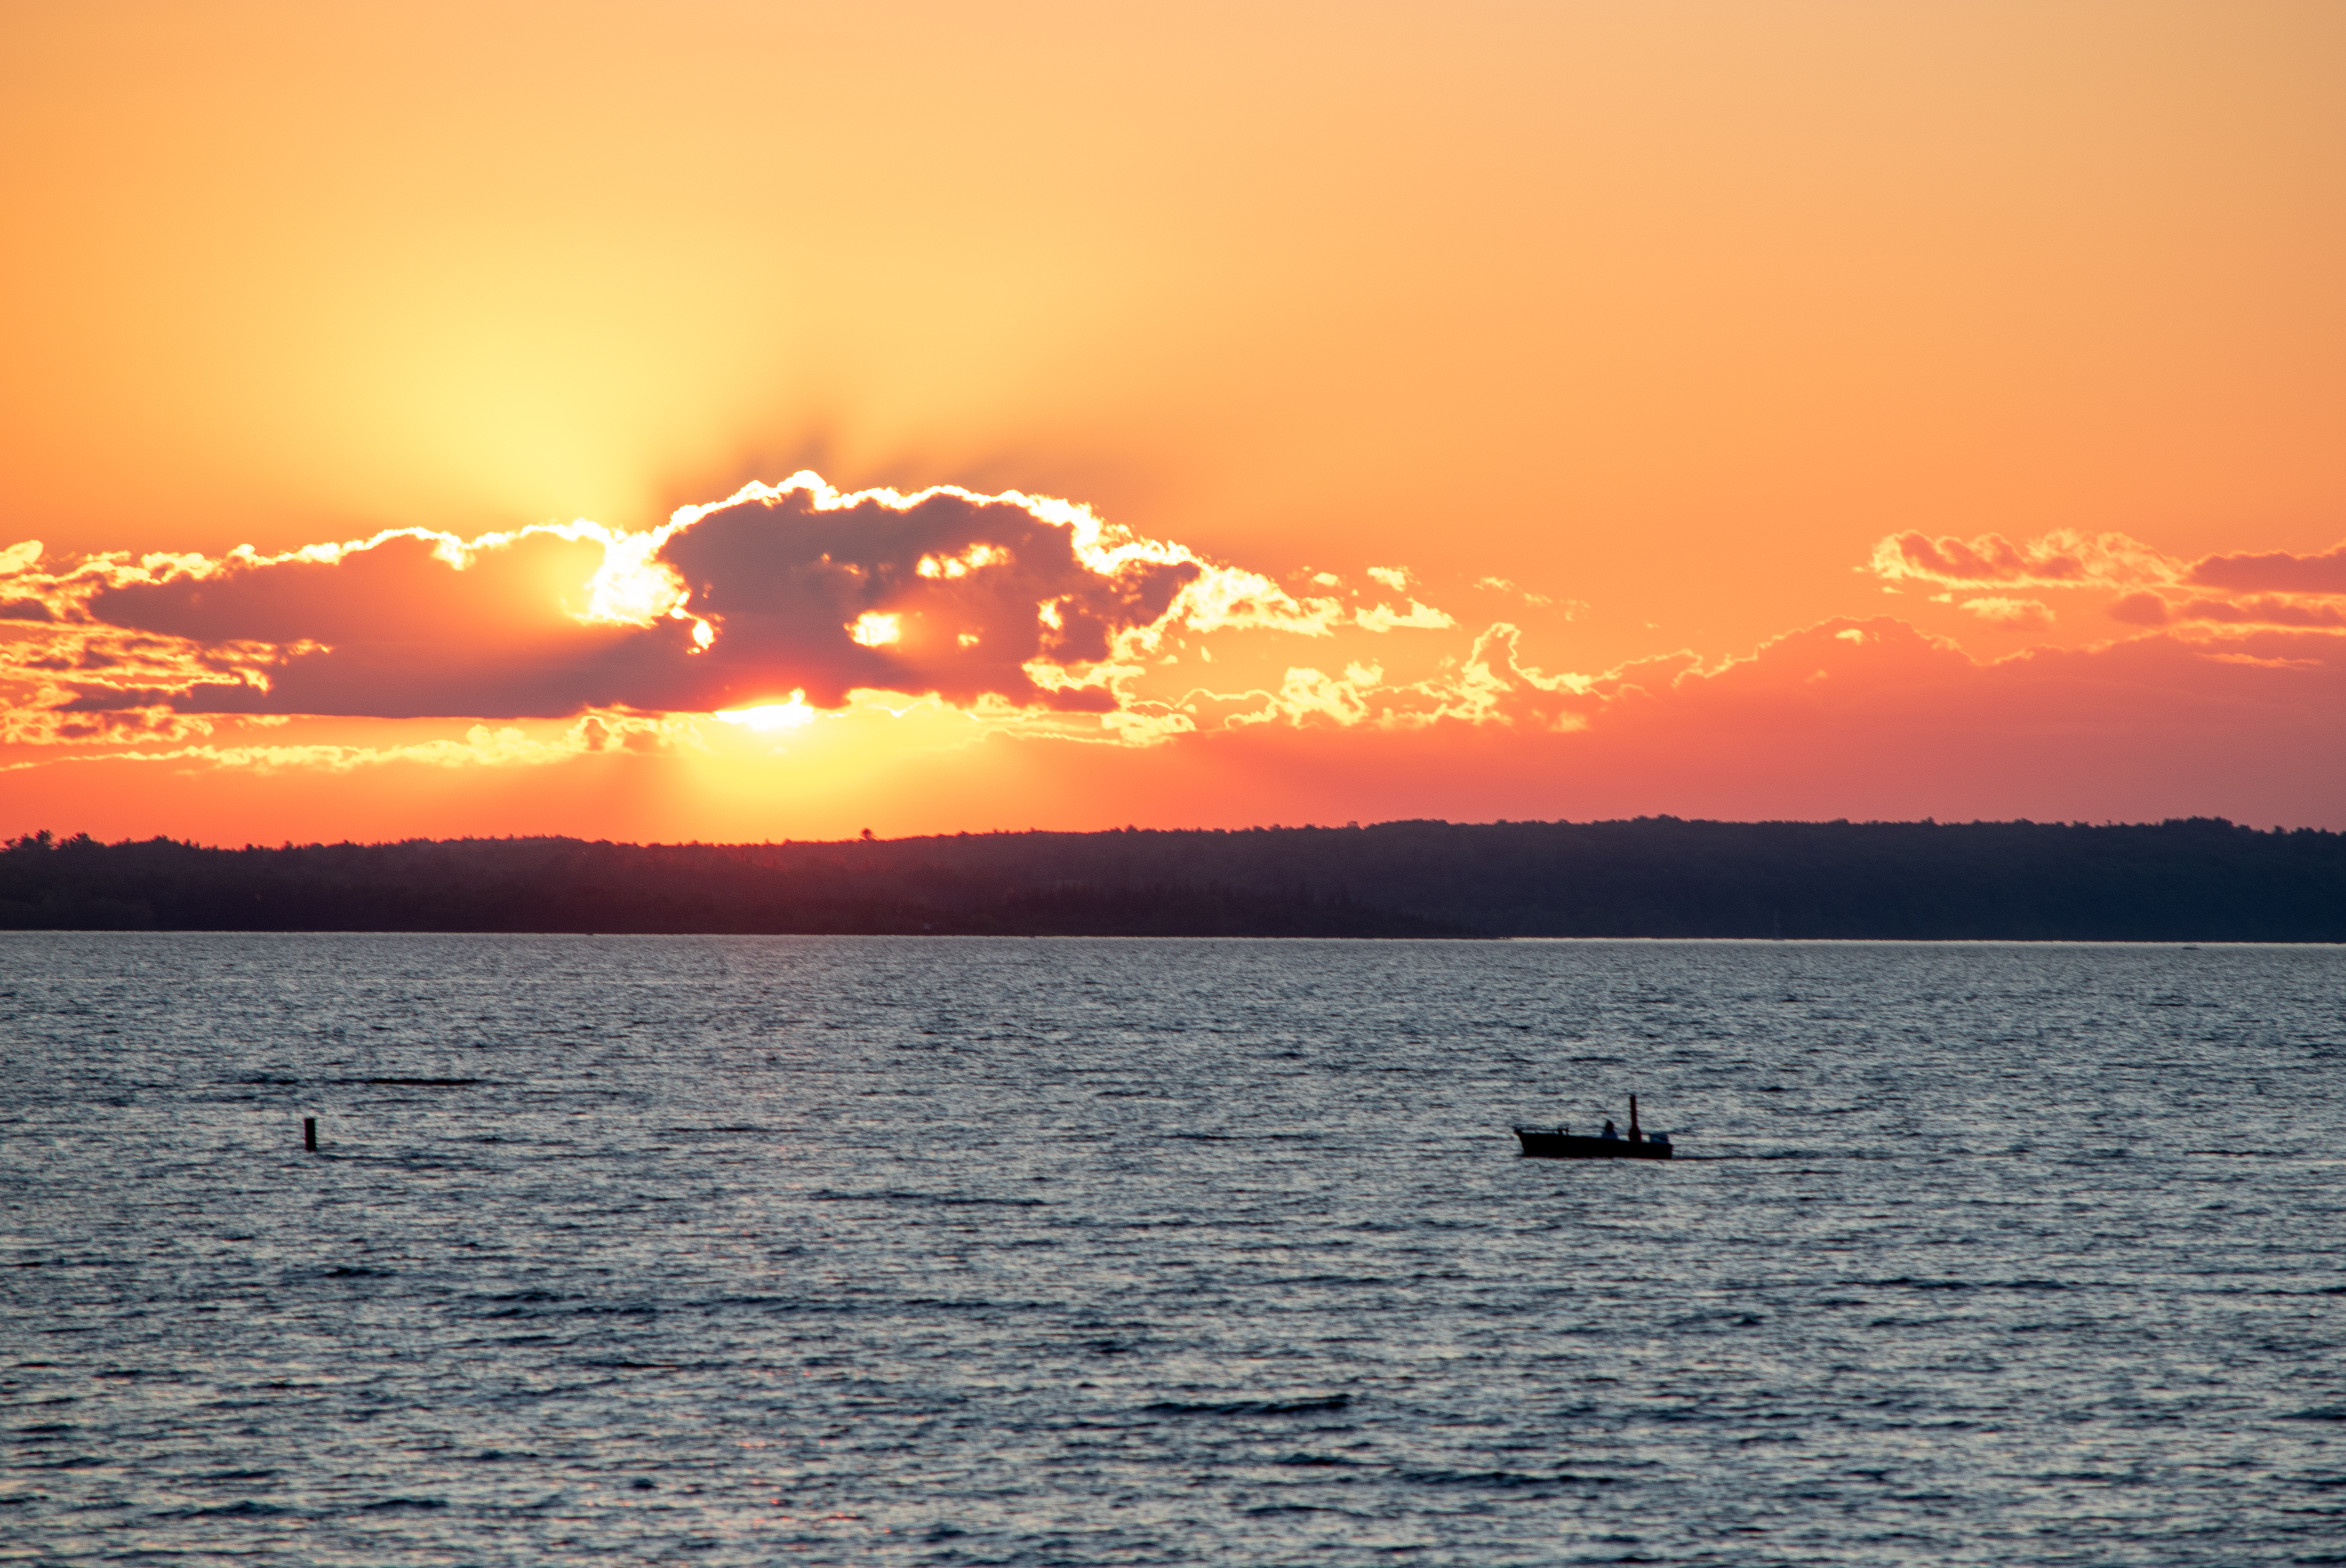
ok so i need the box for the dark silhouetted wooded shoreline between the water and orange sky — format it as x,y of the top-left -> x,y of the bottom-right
0,817 -> 2346,941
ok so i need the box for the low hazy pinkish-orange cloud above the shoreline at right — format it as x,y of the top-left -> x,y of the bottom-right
1191,617 -> 2346,826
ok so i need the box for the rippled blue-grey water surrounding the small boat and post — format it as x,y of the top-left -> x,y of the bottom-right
0,932 -> 2346,1568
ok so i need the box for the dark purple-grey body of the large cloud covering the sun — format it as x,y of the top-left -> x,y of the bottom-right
48,488 -> 1201,718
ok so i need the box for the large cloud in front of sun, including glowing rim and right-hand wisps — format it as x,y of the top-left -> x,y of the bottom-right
0,474 -> 1398,718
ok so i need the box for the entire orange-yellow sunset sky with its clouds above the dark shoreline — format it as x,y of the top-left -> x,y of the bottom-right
0,0 -> 2346,843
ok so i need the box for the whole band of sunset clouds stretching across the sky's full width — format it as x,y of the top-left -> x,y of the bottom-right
0,474 -> 2346,831
